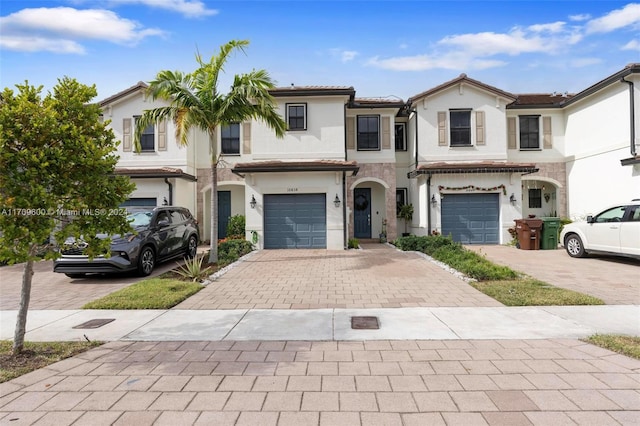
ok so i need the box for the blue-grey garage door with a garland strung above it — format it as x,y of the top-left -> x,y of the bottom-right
442,194 -> 500,244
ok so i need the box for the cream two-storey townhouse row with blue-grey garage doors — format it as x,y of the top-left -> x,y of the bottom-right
100,64 -> 640,249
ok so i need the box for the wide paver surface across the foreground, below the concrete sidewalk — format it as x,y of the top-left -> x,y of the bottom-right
0,340 -> 640,426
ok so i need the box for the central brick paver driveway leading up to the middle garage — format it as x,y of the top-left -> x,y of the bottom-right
175,244 -> 502,309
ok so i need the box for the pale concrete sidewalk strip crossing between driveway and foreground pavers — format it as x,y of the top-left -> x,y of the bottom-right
0,305 -> 640,341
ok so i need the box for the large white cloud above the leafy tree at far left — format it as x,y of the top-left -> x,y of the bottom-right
0,7 -> 164,53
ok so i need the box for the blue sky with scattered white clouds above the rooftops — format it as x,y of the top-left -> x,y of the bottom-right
0,0 -> 640,100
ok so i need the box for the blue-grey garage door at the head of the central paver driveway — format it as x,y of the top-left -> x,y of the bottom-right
264,194 -> 327,249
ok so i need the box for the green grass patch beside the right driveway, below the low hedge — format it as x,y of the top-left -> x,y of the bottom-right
470,278 -> 604,306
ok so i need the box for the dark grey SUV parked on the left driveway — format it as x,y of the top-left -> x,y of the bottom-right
53,206 -> 200,278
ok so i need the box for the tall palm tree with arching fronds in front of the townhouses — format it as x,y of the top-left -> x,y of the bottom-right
134,40 -> 287,263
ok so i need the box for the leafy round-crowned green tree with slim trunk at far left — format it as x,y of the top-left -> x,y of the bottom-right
0,77 -> 133,354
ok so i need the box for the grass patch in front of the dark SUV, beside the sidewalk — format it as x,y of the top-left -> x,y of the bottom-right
82,278 -> 203,309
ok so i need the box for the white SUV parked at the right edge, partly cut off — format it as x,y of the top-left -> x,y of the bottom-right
560,199 -> 640,259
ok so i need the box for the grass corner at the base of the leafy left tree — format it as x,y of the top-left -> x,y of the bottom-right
0,340 -> 102,383
